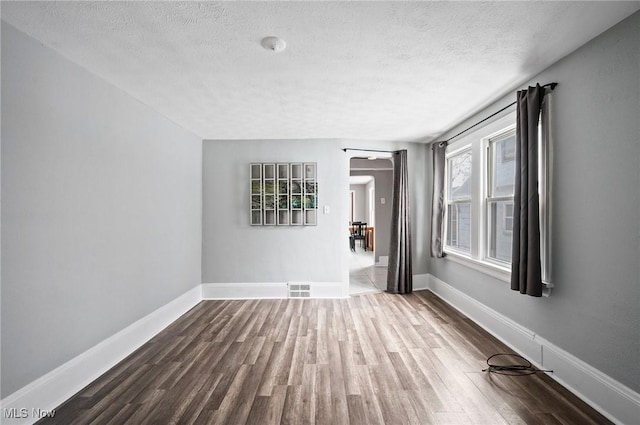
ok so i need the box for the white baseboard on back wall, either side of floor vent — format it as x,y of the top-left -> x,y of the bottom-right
202,281 -> 345,300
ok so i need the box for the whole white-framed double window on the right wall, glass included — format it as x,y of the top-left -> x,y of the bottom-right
444,107 -> 551,283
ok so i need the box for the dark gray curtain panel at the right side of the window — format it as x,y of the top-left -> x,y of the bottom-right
511,84 -> 545,297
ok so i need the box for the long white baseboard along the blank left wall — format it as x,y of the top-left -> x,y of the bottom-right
0,285 -> 202,425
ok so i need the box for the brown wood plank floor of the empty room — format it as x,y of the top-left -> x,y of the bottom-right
39,291 -> 610,425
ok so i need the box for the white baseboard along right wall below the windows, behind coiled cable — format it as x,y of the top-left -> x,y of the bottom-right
424,275 -> 640,425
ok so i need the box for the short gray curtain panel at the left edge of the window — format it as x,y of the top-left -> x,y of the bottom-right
431,142 -> 447,258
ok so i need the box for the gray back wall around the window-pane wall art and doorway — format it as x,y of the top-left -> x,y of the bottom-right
202,140 -> 428,285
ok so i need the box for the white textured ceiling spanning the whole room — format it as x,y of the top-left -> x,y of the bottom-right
1,1 -> 640,141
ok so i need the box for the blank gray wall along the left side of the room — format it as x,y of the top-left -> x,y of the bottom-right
2,22 -> 202,397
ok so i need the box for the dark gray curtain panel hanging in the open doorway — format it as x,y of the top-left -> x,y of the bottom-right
387,150 -> 413,294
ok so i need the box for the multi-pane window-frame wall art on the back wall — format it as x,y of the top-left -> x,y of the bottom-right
249,162 -> 318,226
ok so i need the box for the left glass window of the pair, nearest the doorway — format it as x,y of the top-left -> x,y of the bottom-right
446,149 -> 472,253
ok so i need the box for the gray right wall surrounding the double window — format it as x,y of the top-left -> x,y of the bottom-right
428,13 -> 640,391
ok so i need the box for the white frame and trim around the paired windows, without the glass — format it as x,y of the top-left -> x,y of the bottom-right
444,105 -> 553,290
